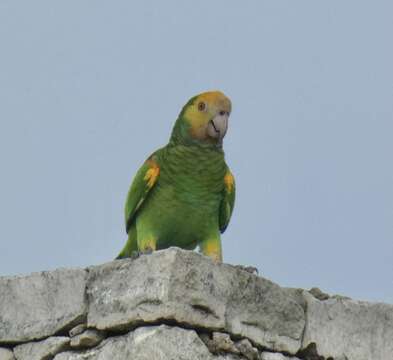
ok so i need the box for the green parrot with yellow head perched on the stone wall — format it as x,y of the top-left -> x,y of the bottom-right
117,91 -> 235,262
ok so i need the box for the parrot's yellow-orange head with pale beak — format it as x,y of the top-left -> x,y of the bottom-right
171,91 -> 231,146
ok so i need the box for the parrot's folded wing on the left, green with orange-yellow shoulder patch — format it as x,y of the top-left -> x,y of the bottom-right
124,154 -> 160,233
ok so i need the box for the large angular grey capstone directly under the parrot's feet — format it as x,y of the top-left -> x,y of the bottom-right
88,249 -> 225,330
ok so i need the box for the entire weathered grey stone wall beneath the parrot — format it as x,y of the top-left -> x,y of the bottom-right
0,248 -> 393,360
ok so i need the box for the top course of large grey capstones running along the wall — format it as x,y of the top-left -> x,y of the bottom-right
0,248 -> 393,360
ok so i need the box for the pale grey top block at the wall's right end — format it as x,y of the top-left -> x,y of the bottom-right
302,292 -> 393,360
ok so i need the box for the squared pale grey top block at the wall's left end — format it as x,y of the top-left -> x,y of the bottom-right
0,269 -> 86,344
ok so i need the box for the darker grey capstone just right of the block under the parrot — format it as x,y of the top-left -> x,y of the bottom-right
223,265 -> 305,353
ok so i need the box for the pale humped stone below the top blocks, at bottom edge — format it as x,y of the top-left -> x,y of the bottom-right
54,325 -> 239,360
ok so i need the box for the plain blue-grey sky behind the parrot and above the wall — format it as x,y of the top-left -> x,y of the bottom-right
0,0 -> 393,302
